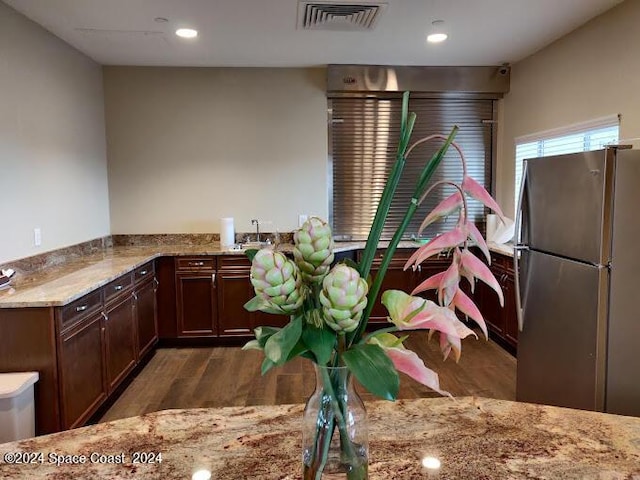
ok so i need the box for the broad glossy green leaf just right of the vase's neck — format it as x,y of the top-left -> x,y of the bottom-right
342,344 -> 400,400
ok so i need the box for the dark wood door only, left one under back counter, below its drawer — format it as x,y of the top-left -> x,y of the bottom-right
176,272 -> 218,337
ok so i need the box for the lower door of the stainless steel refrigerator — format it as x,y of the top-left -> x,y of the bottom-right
516,251 -> 608,411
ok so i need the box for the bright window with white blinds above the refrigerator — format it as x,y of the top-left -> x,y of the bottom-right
515,115 -> 620,210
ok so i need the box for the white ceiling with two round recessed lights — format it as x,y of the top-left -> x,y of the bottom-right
4,0 -> 621,67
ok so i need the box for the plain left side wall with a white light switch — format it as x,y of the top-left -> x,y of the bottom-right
0,2 -> 109,263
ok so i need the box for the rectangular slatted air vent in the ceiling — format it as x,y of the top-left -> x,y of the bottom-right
298,1 -> 387,32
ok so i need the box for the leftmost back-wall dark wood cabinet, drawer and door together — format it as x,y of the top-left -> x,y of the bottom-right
176,257 -> 218,337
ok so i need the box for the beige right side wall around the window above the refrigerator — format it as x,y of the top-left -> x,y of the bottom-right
497,0 -> 640,214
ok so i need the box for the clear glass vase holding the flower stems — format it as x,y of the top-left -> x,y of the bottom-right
302,364 -> 369,480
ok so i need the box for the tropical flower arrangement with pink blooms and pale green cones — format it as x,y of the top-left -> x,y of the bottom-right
244,93 -> 503,479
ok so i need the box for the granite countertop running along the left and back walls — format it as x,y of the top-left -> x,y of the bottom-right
0,241 -> 513,308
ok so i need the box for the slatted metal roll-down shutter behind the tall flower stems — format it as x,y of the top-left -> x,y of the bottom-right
329,98 -> 493,240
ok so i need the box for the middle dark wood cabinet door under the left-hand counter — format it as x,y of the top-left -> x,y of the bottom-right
104,294 -> 137,392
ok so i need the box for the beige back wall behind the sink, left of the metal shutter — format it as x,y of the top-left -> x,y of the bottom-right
104,67 -> 328,234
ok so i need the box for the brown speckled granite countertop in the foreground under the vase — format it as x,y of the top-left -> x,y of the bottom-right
0,397 -> 640,480
